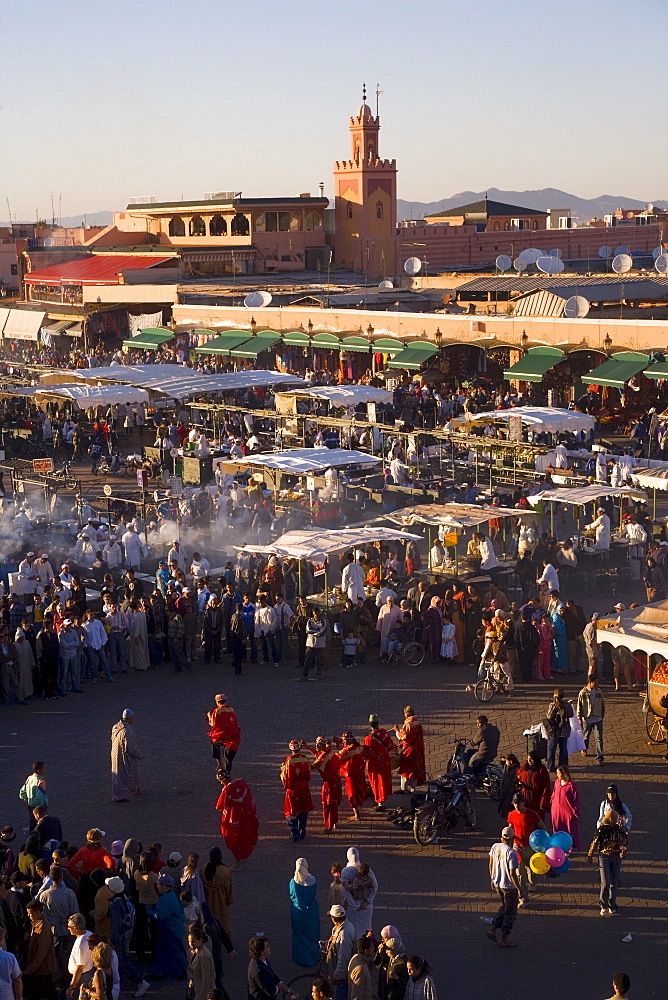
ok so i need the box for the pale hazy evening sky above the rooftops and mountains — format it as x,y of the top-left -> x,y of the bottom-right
0,0 -> 668,218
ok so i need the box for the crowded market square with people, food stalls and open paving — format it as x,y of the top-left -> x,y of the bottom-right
0,336 -> 668,1000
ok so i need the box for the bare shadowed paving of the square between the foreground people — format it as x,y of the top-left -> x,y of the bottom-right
0,636 -> 668,1000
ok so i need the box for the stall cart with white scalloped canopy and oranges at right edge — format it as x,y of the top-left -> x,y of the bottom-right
596,601 -> 668,743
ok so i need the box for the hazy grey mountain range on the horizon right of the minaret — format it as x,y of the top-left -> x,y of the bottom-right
397,188 -> 668,222
